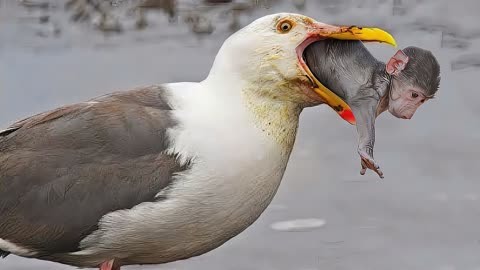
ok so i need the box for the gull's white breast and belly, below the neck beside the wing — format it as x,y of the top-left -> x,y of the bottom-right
72,80 -> 295,264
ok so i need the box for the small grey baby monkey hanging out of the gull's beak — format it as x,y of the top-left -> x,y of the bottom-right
304,39 -> 440,178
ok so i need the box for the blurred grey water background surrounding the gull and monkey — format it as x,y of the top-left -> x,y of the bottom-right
0,0 -> 480,270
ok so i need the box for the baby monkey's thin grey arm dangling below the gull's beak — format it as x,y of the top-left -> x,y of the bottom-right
350,96 -> 383,178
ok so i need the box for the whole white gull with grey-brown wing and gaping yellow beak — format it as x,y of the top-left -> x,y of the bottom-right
0,13 -> 395,270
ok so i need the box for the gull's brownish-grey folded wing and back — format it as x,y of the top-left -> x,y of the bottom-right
0,87 -> 188,255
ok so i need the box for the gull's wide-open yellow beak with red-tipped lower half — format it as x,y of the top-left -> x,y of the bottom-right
296,24 -> 396,124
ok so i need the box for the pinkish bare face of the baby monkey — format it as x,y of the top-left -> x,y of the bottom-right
388,80 -> 428,119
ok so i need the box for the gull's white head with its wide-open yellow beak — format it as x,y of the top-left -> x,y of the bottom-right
209,13 -> 395,122
